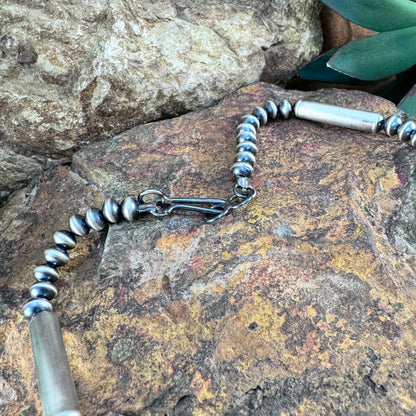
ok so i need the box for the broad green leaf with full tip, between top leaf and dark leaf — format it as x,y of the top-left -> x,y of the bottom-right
328,26 -> 416,80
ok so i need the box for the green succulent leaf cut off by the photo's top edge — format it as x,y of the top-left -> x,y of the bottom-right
322,0 -> 416,32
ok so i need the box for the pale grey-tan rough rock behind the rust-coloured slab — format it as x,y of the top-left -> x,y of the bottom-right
0,0 -> 321,197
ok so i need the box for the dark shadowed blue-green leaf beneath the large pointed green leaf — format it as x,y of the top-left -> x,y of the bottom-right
299,47 -> 382,85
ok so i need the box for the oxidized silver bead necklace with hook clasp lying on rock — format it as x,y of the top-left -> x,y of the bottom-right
23,95 -> 416,416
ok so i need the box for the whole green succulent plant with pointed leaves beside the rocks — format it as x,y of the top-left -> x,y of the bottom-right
300,0 -> 416,116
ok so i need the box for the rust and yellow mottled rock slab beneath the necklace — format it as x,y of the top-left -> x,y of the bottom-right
0,84 -> 416,416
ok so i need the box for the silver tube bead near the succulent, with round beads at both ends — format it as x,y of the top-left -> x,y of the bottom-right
294,100 -> 383,133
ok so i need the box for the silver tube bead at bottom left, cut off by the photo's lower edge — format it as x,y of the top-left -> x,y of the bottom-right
29,311 -> 81,416
